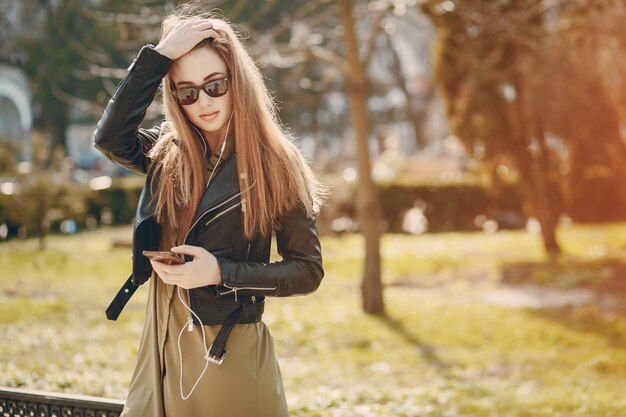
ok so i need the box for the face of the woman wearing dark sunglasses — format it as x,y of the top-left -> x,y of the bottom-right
172,47 -> 233,149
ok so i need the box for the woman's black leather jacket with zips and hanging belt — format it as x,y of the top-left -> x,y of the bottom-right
94,45 -> 324,324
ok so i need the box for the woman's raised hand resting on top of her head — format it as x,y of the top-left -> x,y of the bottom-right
154,19 -> 217,59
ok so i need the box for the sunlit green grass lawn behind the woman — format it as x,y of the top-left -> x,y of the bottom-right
0,224 -> 626,417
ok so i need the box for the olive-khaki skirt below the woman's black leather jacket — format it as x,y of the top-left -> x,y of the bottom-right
121,229 -> 289,417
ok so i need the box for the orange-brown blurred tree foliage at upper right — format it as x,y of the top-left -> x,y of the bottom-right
421,0 -> 626,252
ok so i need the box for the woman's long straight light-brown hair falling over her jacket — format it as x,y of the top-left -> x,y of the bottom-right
149,6 -> 325,239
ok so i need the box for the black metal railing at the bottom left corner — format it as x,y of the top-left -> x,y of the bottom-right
0,387 -> 124,417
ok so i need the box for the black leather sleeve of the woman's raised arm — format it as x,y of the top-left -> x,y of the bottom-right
93,45 -> 173,174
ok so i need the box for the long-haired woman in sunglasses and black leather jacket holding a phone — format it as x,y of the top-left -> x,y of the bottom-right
94,9 -> 324,417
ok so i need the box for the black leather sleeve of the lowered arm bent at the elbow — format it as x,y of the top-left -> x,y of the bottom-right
217,206 -> 324,298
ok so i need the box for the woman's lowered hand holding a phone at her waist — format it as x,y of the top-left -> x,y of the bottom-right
146,245 -> 222,289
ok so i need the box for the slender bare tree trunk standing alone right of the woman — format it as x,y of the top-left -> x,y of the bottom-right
339,0 -> 385,316
